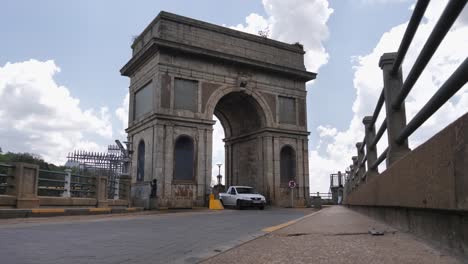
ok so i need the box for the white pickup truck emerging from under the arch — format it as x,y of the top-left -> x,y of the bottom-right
219,186 -> 266,210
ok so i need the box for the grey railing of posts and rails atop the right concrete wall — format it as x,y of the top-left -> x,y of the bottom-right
345,0 -> 468,193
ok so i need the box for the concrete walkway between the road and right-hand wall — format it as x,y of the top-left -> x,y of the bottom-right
203,206 -> 462,264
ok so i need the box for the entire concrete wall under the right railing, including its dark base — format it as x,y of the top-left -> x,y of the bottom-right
344,114 -> 468,258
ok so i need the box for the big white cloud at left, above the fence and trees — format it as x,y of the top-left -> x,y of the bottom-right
0,60 -> 112,164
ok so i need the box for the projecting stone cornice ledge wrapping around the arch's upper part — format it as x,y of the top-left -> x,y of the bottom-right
120,38 -> 317,81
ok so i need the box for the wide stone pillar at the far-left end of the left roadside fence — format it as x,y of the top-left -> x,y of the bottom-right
14,162 -> 39,208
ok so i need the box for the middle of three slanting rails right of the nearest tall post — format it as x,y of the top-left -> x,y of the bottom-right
392,0 -> 467,110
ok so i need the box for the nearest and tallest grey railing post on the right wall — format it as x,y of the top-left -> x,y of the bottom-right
379,53 -> 409,167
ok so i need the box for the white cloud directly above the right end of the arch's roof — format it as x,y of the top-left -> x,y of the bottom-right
232,0 -> 333,72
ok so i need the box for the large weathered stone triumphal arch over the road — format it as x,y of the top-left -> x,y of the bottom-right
121,12 -> 316,208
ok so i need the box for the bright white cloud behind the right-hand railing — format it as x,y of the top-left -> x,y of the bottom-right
310,1 -> 468,191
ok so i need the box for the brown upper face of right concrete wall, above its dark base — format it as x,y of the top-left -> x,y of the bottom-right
344,113 -> 468,211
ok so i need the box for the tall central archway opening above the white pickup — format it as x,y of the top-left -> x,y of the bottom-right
212,92 -> 266,192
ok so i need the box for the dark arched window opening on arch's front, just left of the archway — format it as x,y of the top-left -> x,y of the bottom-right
174,136 -> 195,181
